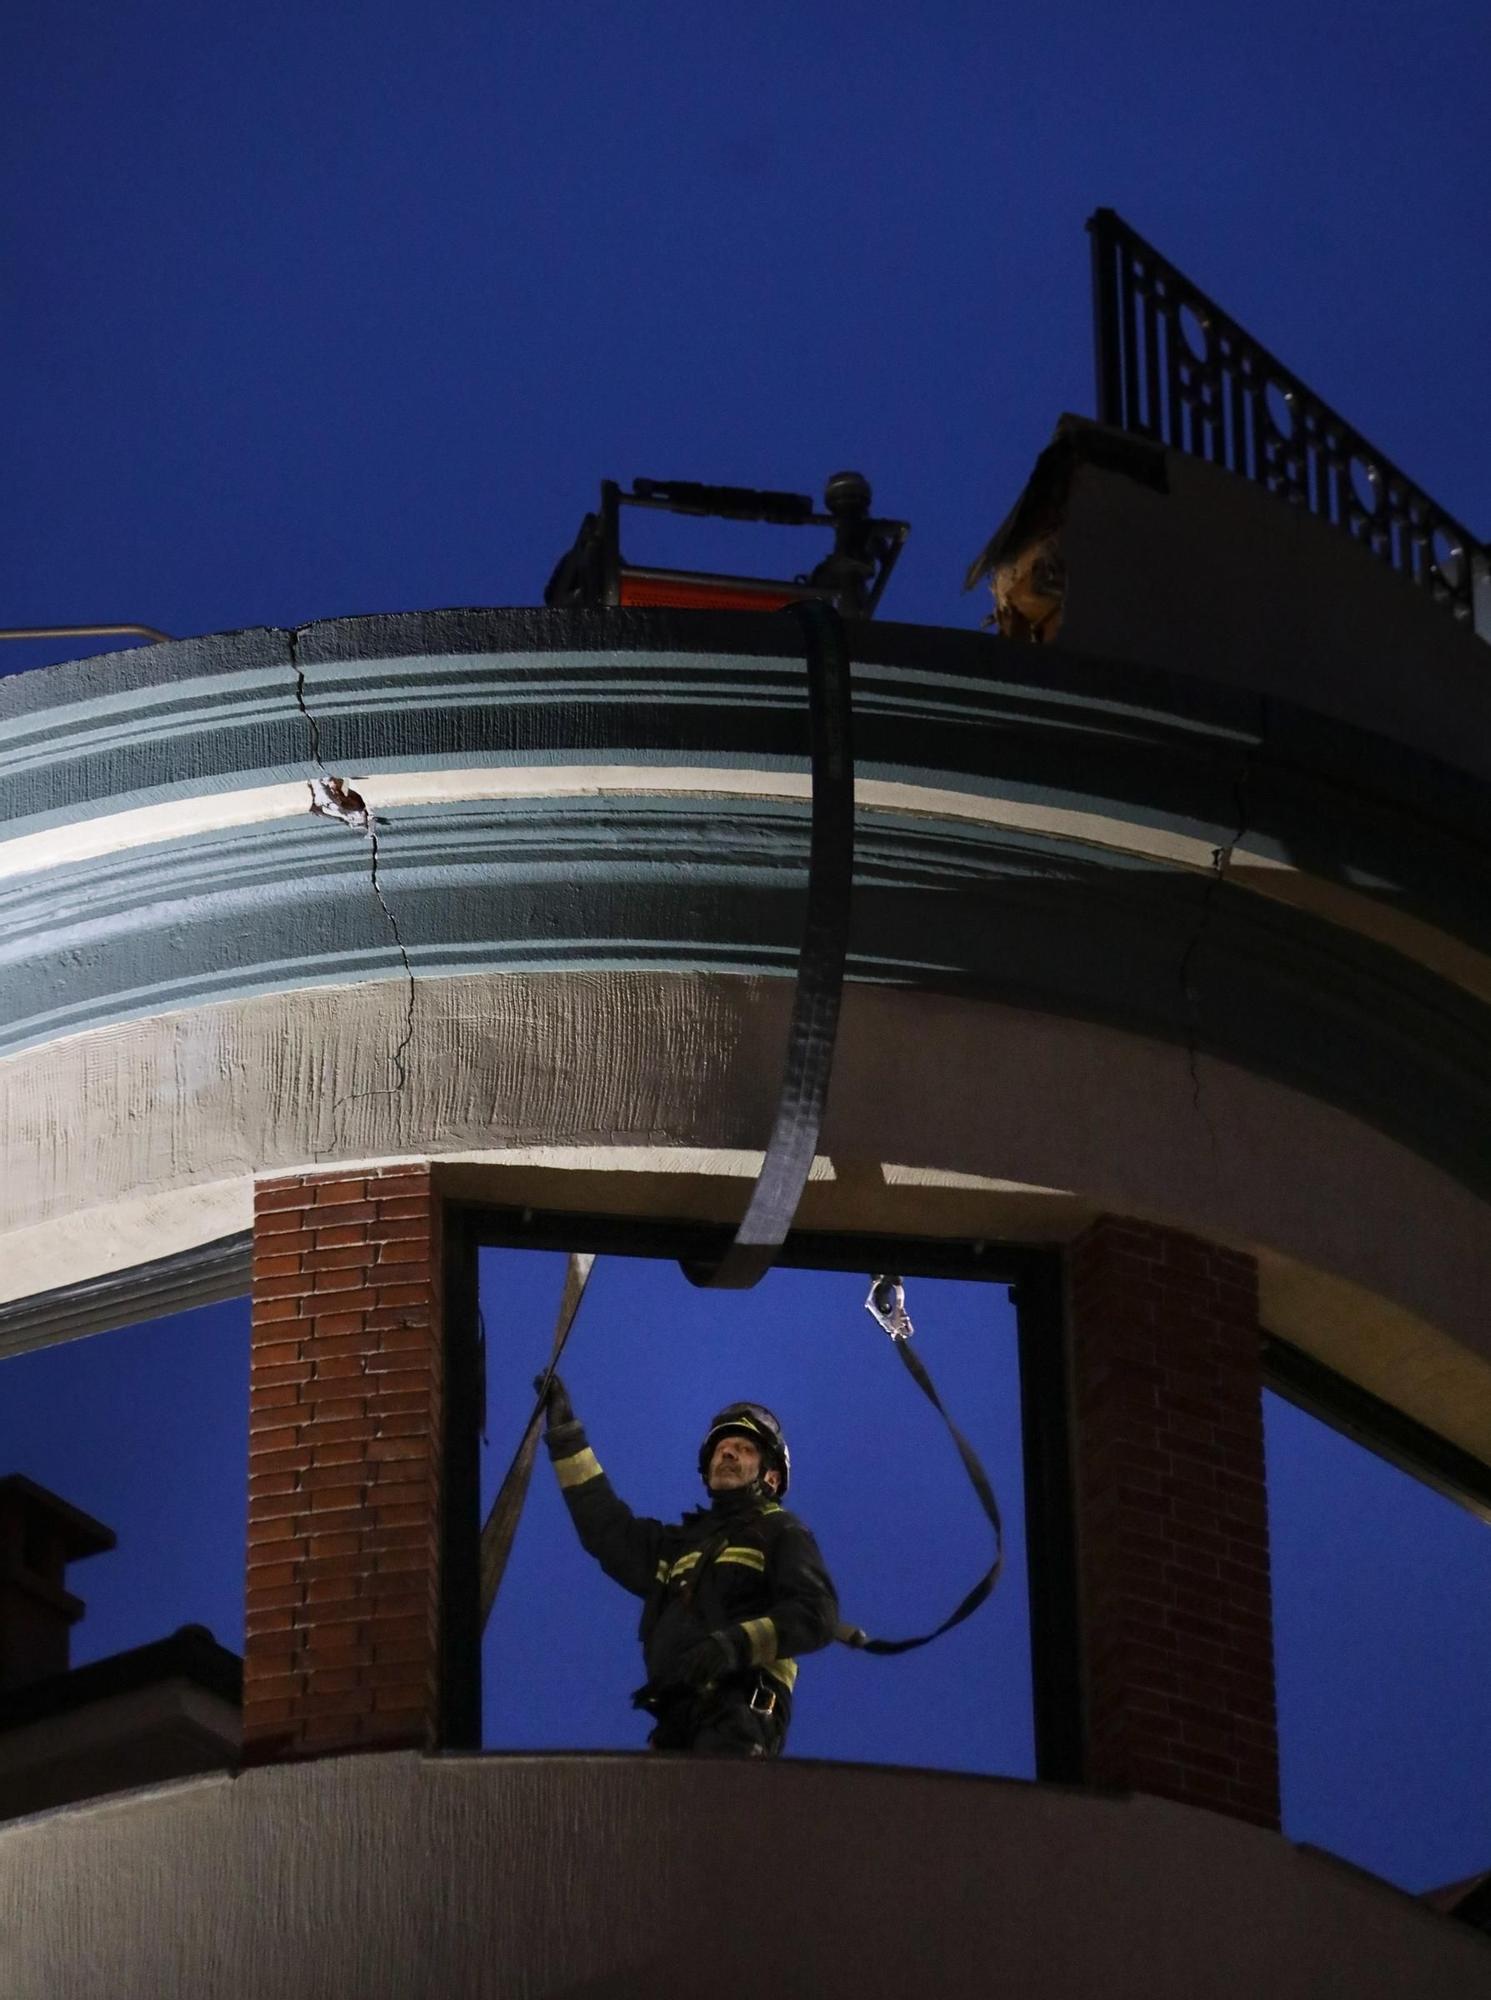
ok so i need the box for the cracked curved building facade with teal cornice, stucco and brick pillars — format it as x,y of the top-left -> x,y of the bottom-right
0,422 -> 1491,1996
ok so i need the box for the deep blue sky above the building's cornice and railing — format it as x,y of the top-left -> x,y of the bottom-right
0,0 -> 1491,664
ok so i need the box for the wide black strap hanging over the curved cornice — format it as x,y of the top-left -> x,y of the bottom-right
682,598 -> 853,1290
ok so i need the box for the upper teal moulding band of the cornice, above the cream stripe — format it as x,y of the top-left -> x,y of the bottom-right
0,614 -> 1491,960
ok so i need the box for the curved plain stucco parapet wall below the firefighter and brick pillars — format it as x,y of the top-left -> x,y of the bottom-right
0,1754 -> 1491,2000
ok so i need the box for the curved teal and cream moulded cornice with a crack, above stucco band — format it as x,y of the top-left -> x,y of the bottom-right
0,610 -> 1491,1216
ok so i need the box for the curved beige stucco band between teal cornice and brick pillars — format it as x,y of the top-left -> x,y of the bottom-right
0,972 -> 1491,1458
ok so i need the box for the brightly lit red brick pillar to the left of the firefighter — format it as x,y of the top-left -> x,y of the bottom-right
244,1166 -> 444,1762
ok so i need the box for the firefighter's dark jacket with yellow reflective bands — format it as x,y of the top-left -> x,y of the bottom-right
548,1424 -> 839,1690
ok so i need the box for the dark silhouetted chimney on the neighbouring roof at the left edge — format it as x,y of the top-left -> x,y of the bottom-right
0,1472 -> 116,1694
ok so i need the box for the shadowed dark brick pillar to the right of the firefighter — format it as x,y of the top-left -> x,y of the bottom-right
1069,1216 -> 1279,1826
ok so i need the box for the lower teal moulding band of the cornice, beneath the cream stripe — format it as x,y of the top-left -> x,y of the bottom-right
0,800 -> 1491,1188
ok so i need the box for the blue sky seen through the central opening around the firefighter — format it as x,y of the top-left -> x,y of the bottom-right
480,1248 -> 1035,1776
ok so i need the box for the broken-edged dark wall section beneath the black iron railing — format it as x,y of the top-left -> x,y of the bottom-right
967,414 -> 1491,782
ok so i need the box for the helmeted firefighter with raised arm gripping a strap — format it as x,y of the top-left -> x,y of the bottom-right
536,1376 -> 839,1756
